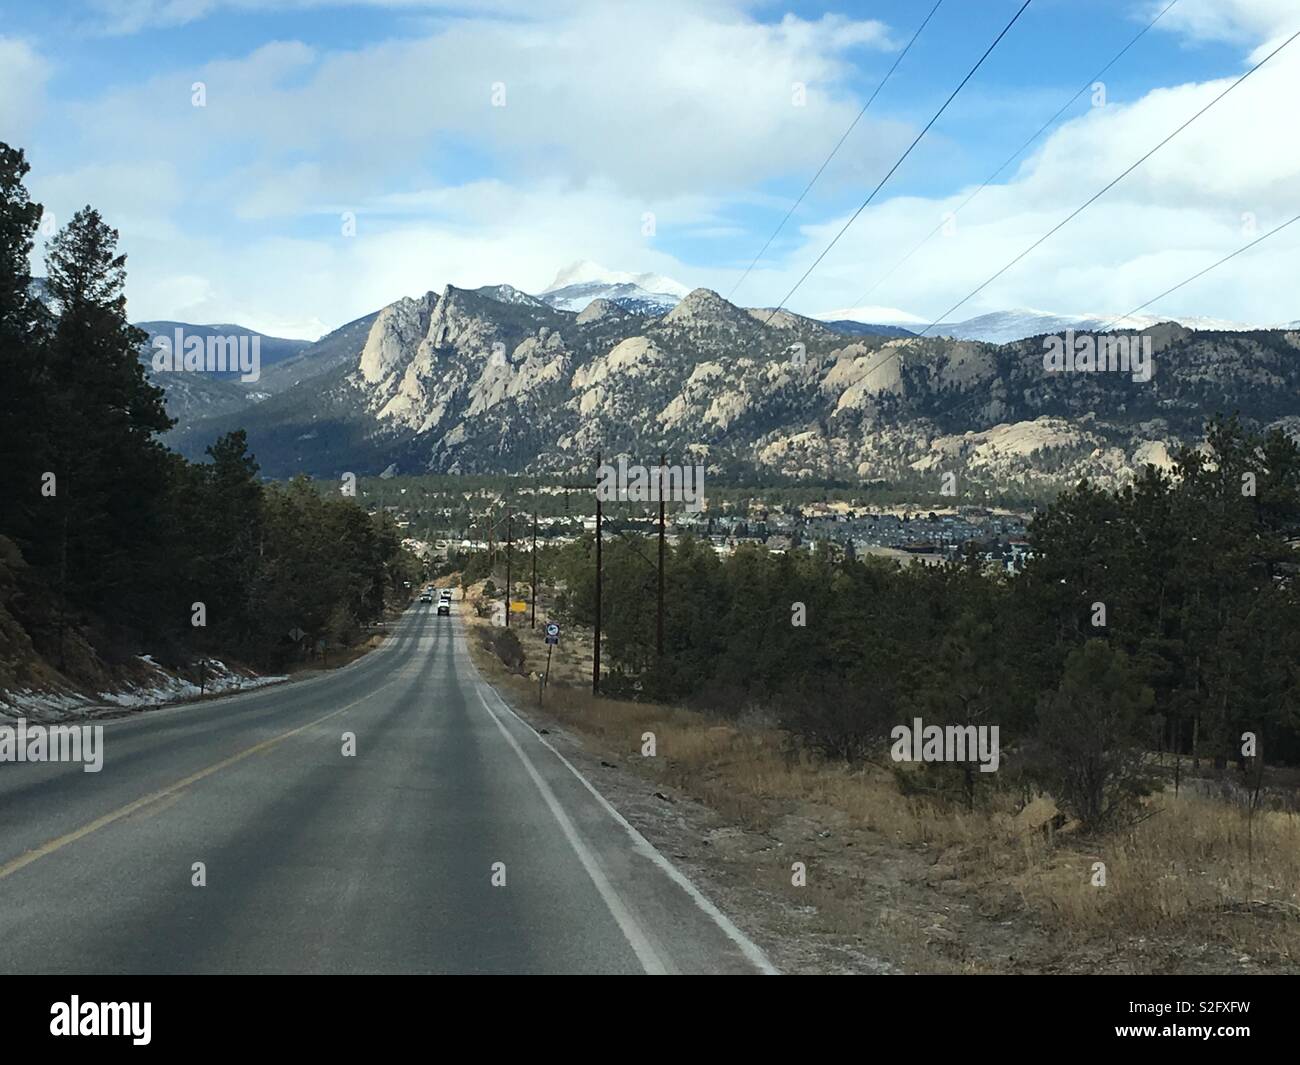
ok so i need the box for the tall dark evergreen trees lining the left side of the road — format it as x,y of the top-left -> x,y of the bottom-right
0,143 -> 413,683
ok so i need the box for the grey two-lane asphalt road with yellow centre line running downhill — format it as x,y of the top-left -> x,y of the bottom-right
0,605 -> 768,974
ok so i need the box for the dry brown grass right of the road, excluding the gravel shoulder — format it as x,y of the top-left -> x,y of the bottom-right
467,603 -> 1300,971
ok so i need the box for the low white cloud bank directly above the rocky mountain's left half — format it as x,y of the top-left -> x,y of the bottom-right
110,181 -> 712,339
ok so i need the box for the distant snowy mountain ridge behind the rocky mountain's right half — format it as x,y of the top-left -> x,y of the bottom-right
816,307 -> 1258,343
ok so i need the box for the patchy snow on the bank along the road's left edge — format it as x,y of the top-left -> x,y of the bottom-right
0,654 -> 287,722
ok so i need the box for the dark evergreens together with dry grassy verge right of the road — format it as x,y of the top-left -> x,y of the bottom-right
467,417 -> 1300,971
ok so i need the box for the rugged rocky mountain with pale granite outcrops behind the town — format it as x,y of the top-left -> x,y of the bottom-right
172,282 -> 1300,488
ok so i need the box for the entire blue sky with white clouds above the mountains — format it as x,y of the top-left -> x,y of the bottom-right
0,0 -> 1300,339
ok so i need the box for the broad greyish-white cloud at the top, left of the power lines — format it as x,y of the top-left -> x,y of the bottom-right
65,0 -> 905,205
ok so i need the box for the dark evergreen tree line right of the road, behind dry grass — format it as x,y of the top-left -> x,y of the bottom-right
546,417 -> 1300,821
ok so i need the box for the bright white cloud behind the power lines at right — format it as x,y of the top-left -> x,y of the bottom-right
745,23 -> 1300,324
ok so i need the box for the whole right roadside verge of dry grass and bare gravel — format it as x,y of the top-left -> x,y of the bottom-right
471,618 -> 1300,974
